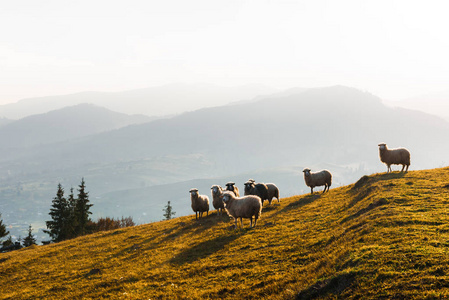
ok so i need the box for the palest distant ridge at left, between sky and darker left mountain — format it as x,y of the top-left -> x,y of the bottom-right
0,84 -> 276,119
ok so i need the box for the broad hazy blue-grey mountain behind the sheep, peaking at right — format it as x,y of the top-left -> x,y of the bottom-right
0,86 -> 449,241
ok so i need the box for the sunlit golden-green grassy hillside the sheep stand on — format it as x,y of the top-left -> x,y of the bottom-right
0,168 -> 449,299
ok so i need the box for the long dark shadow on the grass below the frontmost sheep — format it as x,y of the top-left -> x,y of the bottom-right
170,230 -> 246,265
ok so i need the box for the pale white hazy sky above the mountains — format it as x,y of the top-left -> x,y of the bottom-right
0,0 -> 449,104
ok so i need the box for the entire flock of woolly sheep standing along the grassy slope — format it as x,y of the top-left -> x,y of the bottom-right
186,143 -> 410,228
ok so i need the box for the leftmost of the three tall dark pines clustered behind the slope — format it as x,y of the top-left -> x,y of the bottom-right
44,183 -> 69,242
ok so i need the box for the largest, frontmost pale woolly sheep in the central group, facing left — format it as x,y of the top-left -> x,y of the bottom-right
223,191 -> 262,229
